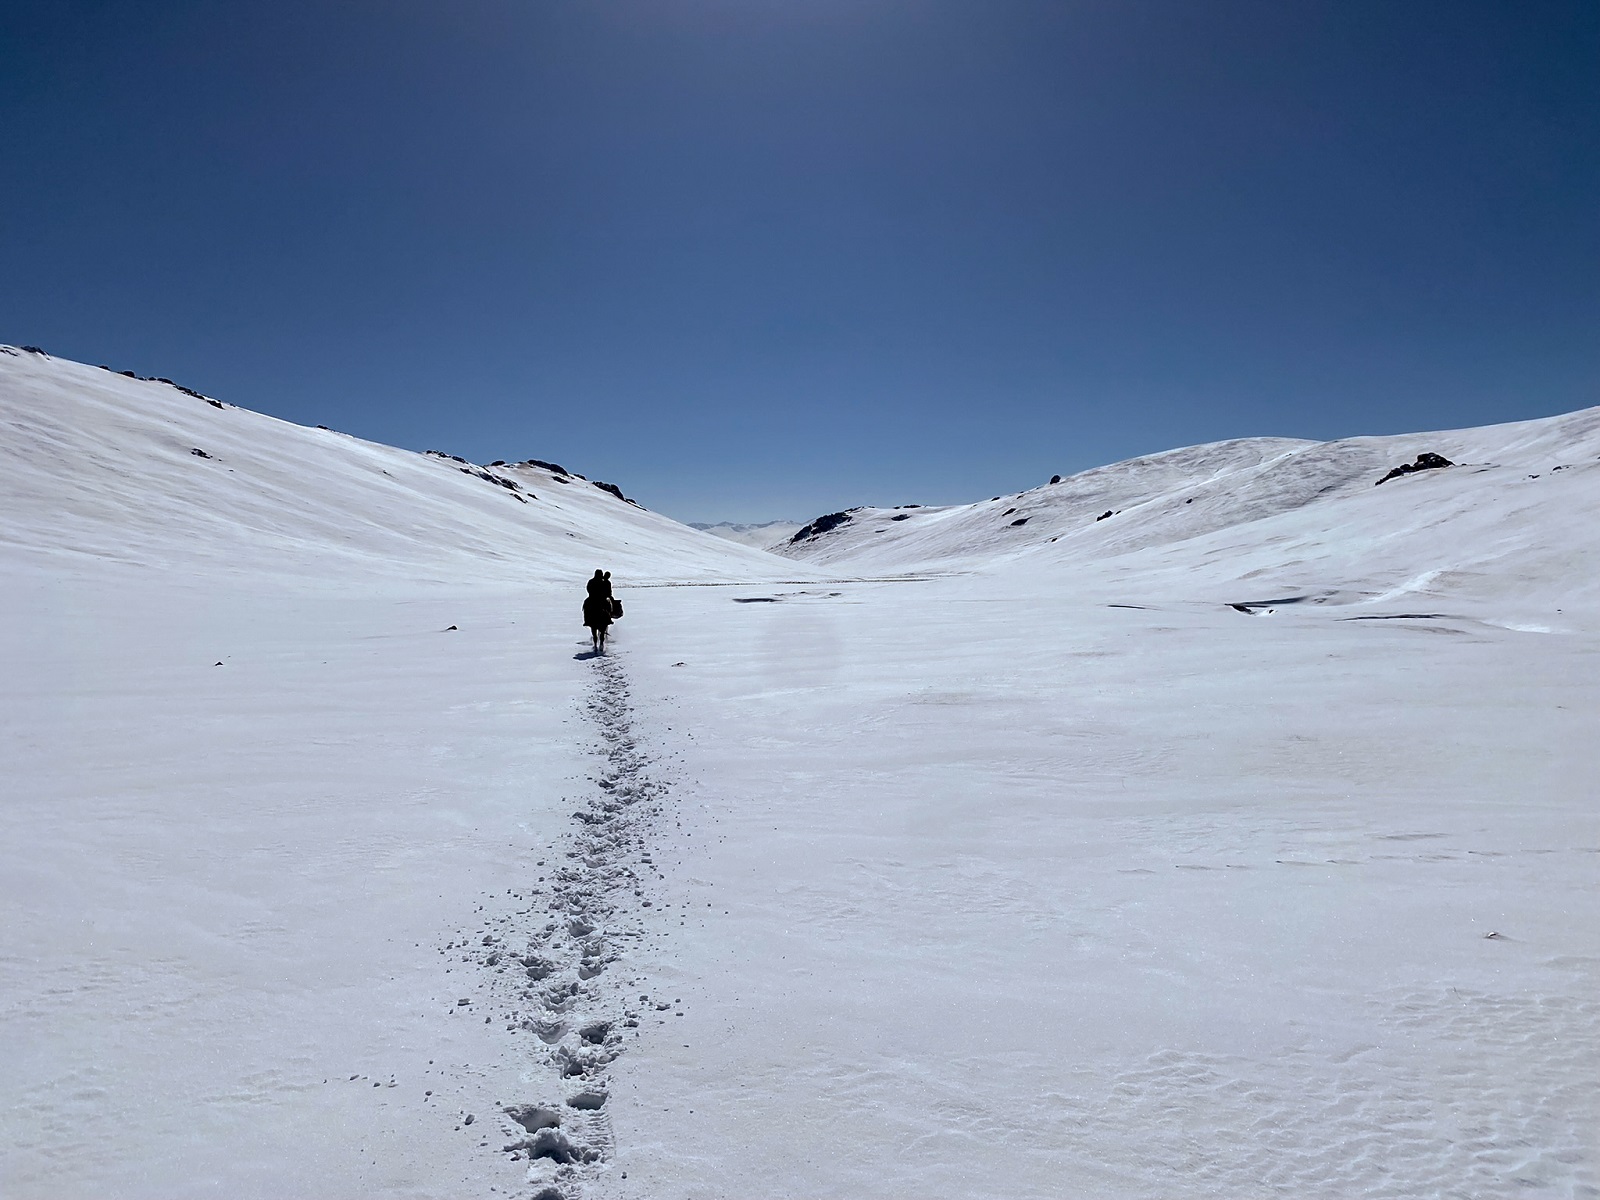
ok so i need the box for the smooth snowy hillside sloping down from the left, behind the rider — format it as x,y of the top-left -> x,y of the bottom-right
0,347 -> 795,581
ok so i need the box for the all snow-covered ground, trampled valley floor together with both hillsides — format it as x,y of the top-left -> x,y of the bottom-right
0,342 -> 1600,1200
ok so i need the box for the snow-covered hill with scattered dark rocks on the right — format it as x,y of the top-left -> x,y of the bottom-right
778,408 -> 1600,614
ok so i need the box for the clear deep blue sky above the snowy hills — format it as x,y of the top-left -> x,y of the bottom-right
0,0 -> 1600,520
